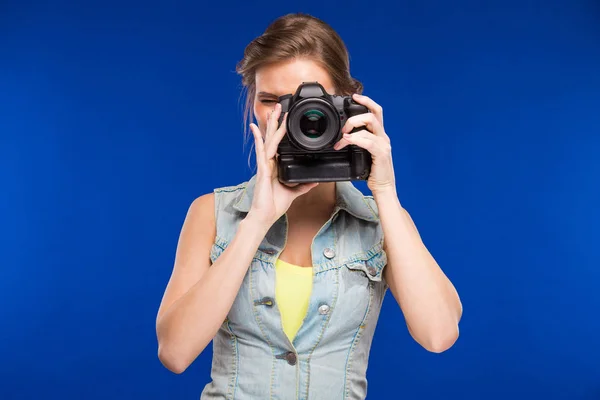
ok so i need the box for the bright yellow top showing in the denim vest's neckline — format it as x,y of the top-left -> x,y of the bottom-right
275,259 -> 312,342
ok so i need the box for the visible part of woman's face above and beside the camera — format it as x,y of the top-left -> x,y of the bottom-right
254,59 -> 335,135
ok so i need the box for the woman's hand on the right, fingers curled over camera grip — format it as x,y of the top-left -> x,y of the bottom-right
334,94 -> 396,195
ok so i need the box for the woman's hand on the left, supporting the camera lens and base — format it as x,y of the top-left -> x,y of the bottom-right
248,103 -> 318,227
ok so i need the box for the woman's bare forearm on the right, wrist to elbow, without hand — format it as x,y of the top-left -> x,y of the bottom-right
375,191 -> 462,351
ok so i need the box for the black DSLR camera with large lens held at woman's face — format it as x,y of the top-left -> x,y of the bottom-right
277,82 -> 371,183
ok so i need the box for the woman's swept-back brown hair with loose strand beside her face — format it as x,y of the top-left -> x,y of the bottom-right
236,13 -> 363,142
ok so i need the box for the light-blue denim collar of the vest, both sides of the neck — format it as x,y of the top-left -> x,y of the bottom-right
233,175 -> 379,221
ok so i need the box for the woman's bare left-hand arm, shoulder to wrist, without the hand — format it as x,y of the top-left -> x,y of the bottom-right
156,194 -> 268,373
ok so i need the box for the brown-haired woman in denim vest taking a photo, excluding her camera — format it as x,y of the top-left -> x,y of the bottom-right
157,14 -> 462,400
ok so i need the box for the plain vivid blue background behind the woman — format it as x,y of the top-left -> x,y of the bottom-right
0,0 -> 600,400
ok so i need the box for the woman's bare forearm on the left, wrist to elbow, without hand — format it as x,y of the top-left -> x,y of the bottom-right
157,218 -> 268,371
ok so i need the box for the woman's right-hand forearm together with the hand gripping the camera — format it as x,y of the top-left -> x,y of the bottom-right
336,95 -> 462,353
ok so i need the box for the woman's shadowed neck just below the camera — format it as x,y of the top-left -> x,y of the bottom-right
288,182 -> 336,218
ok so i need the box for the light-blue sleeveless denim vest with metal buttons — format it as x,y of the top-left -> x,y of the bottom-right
201,176 -> 388,400
